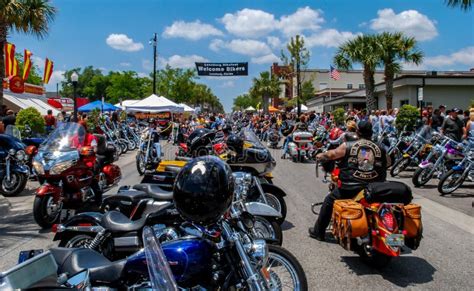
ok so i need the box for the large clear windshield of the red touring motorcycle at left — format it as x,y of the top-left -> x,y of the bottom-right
40,122 -> 86,152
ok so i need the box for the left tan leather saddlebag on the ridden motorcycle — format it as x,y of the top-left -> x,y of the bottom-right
332,199 -> 369,249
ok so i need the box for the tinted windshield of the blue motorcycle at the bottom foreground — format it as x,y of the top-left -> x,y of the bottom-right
142,227 -> 178,290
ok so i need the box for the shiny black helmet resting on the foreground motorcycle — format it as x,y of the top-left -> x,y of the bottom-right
173,156 -> 234,224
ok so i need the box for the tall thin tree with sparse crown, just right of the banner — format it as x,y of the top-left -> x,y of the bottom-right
281,35 -> 310,115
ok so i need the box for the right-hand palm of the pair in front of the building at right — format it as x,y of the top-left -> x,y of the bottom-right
376,32 -> 423,109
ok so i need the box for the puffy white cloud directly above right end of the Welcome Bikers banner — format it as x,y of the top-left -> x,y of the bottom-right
220,8 -> 278,37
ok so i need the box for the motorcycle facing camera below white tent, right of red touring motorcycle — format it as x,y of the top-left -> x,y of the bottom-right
136,126 -> 162,176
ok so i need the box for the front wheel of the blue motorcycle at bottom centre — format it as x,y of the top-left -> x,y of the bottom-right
265,245 -> 308,291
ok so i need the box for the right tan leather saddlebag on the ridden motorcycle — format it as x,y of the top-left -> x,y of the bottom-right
403,203 -> 423,250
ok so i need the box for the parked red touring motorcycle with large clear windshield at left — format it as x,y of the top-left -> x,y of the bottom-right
33,123 -> 122,228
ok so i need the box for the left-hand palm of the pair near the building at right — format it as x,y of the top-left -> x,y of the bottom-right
334,35 -> 380,111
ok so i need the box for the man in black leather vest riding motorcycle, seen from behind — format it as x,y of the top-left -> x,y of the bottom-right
309,121 -> 387,241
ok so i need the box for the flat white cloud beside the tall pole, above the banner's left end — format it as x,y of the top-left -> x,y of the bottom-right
163,20 -> 224,40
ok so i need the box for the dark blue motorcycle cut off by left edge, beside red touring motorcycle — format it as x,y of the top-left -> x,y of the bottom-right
0,134 -> 30,197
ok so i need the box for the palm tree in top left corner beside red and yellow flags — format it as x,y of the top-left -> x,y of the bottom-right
0,0 -> 56,106
